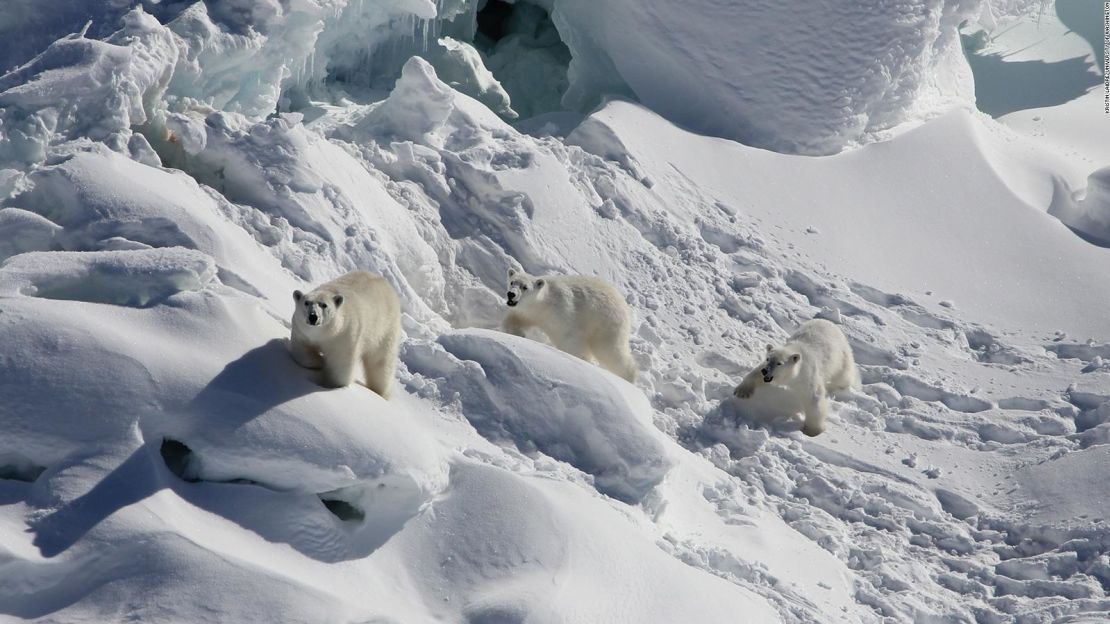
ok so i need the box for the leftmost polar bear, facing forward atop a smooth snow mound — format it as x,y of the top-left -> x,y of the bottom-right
290,271 -> 401,399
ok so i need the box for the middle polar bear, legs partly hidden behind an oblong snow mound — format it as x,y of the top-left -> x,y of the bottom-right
502,269 -> 636,382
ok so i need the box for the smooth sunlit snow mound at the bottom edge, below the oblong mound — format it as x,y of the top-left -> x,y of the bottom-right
386,463 -> 778,623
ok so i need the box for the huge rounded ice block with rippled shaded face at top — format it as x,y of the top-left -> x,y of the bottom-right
554,0 -> 977,153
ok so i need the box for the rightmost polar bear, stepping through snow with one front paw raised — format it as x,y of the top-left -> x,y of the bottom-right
734,319 -> 859,435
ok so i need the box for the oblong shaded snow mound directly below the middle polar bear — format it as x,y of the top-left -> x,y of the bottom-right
405,330 -> 673,502
